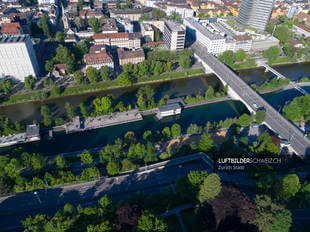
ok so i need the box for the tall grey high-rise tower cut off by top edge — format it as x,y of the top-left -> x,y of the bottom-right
237,0 -> 274,31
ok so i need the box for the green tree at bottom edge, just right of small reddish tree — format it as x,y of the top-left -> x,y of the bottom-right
138,210 -> 167,232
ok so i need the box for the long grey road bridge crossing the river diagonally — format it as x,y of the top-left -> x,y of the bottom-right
191,42 -> 310,158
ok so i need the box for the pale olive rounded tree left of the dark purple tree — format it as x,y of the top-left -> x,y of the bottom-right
199,173 -> 222,203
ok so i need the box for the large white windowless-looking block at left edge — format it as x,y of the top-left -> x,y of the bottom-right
0,35 -> 39,81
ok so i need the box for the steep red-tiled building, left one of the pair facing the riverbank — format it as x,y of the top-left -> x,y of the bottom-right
84,45 -> 114,69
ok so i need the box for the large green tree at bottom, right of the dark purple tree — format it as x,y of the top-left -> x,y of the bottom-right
251,195 -> 292,232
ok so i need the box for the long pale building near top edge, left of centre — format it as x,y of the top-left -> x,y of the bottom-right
110,7 -> 152,21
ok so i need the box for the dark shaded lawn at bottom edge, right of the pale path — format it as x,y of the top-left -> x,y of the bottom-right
181,208 -> 207,232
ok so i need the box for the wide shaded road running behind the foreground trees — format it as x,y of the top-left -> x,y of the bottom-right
0,154 -> 213,231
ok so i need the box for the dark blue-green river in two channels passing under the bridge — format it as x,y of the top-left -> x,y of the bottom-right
0,63 -> 310,155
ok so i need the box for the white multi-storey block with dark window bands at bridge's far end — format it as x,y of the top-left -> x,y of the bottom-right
163,20 -> 186,50
